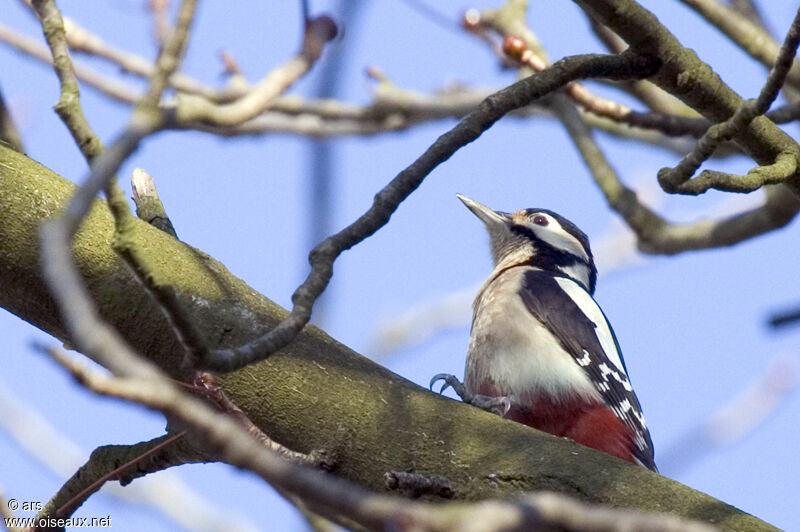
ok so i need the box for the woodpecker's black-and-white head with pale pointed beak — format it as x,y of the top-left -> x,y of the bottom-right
457,194 -> 597,294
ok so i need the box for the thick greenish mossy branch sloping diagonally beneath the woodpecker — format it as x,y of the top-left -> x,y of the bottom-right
0,146 -> 774,530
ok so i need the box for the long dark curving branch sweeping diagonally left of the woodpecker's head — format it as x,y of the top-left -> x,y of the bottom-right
193,53 -> 657,371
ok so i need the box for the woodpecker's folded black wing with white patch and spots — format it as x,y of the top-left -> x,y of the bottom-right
520,269 -> 656,470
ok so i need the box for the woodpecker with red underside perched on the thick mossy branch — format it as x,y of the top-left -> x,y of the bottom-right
431,194 -> 657,471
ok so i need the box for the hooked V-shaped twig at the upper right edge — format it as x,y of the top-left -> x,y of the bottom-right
658,5 -> 800,194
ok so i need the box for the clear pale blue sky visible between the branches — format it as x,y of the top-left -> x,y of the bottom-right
0,0 -> 800,530
